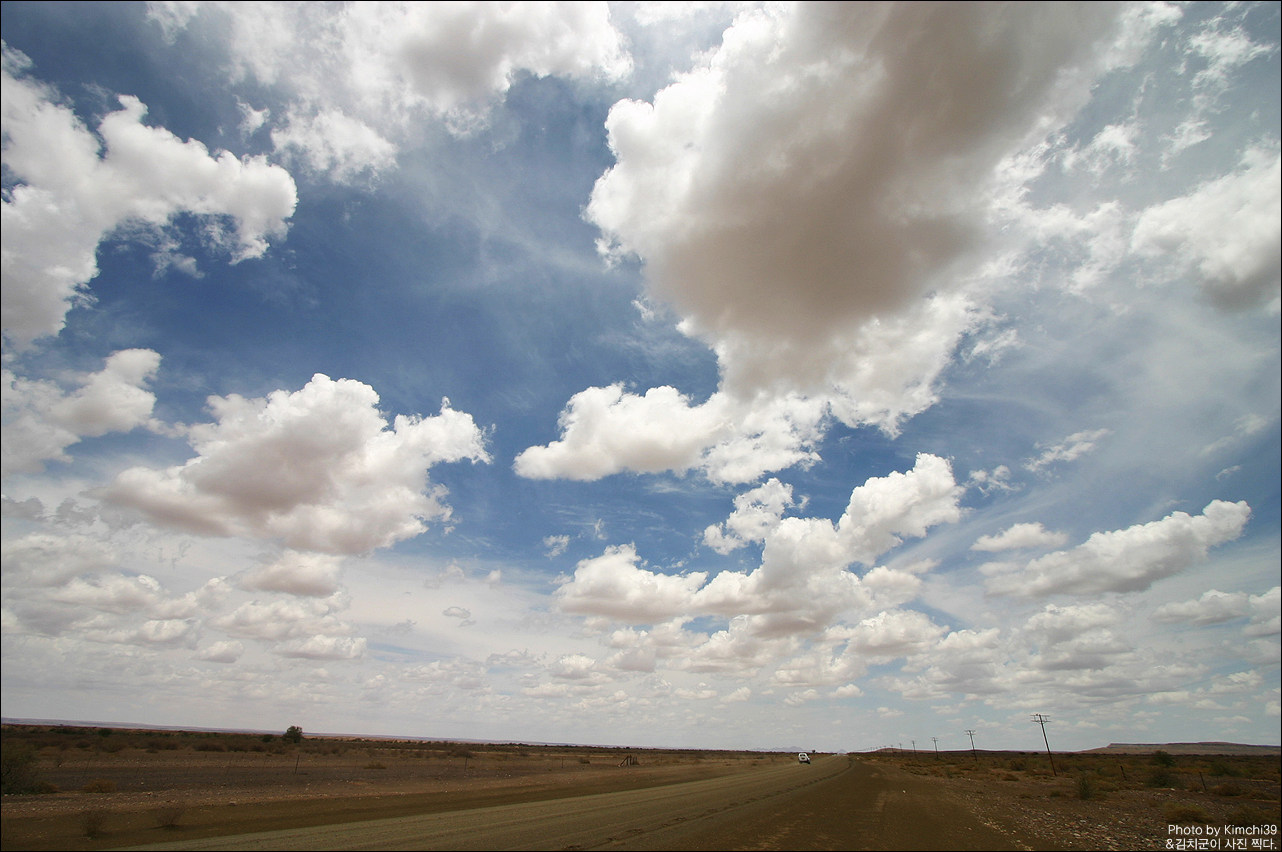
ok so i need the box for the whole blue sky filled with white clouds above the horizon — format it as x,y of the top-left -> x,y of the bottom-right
0,1 -> 1282,752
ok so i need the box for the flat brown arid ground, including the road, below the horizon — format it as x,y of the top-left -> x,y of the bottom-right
0,725 -> 1282,852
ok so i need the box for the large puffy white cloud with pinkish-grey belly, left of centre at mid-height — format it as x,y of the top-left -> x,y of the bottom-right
105,374 -> 490,553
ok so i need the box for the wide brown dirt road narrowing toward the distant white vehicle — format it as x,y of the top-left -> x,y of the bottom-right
117,756 -> 1046,849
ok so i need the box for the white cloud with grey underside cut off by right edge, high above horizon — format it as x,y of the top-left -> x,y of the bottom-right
1131,150 -> 1282,311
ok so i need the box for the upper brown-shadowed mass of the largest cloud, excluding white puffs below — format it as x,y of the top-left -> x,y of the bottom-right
587,4 -> 1153,374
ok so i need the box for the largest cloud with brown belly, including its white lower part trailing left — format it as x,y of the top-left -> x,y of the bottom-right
518,4 -> 1169,482
